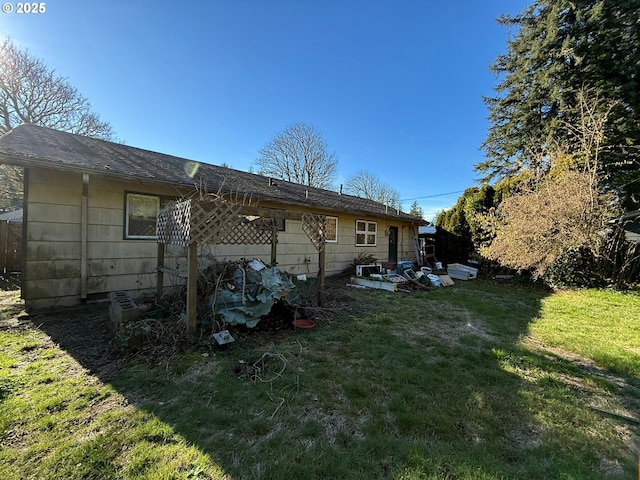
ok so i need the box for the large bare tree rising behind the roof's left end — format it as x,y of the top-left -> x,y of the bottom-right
0,38 -> 113,140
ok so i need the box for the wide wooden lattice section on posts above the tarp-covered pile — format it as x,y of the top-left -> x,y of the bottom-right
157,198 -> 277,246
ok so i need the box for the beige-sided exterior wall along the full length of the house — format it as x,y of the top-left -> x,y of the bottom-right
22,168 -> 415,309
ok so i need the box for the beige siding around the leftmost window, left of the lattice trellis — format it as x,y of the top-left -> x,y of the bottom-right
24,169 -> 165,308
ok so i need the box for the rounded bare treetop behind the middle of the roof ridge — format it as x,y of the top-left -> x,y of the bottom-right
255,123 -> 338,189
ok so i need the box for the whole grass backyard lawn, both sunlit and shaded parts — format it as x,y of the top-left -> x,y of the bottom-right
0,279 -> 640,480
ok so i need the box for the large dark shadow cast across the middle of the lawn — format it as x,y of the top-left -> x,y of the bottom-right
27,279 -> 632,479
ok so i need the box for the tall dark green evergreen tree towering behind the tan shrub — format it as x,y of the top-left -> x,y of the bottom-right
476,0 -> 640,208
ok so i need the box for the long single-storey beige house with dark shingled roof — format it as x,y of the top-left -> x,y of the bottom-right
0,124 -> 421,309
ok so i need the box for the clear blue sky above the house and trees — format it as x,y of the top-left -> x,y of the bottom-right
0,0 -> 529,219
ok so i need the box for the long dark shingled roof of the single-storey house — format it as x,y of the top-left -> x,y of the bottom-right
0,124 -> 421,222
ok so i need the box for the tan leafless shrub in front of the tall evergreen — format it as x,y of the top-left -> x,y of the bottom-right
480,90 -> 618,277
